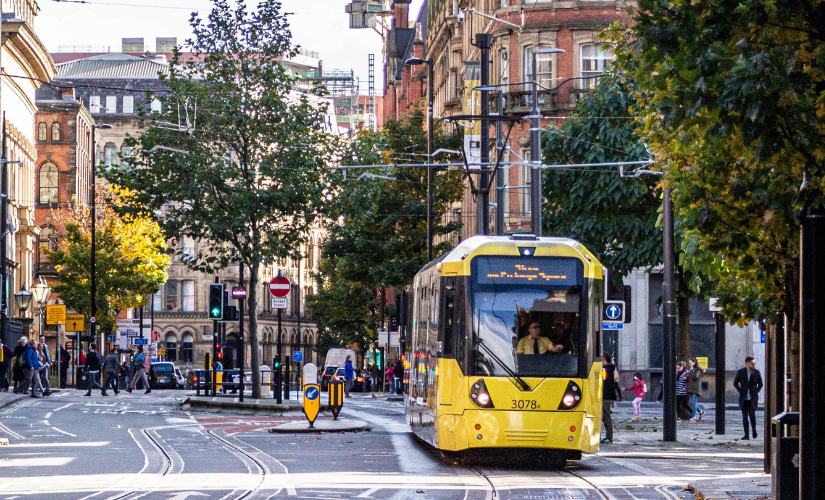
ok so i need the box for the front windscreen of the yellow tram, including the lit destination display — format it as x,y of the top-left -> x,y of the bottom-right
472,256 -> 587,377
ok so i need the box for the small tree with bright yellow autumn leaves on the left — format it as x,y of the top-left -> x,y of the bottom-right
46,186 -> 171,332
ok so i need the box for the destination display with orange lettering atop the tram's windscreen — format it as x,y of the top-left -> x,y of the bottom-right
476,256 -> 581,286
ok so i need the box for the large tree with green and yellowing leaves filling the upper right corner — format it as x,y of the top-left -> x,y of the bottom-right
613,0 -> 825,407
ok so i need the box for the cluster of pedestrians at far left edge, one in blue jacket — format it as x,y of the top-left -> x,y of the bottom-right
0,337 -> 53,398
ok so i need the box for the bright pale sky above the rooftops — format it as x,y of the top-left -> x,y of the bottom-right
35,0 -> 424,92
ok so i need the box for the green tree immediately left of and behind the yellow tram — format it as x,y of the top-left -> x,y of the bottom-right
307,111 -> 462,349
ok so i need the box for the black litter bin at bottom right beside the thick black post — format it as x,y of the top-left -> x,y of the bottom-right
771,412 -> 799,500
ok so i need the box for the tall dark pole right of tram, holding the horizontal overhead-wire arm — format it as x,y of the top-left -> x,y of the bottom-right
662,188 -> 676,441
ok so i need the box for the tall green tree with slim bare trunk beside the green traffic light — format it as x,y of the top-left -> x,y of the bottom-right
107,0 -> 336,397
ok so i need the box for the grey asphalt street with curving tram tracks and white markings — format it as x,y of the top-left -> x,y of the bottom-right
0,391 -> 762,500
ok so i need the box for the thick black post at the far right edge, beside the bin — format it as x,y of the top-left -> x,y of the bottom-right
800,205 -> 825,499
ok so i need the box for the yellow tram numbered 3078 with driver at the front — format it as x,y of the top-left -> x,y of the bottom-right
405,235 -> 603,460
